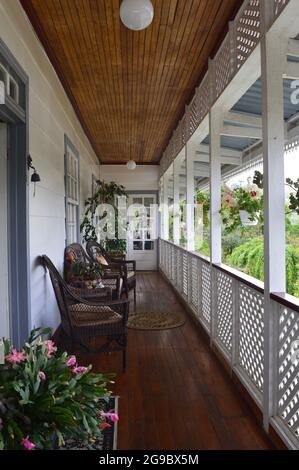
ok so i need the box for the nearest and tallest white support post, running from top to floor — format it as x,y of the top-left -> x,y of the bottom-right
261,1 -> 287,430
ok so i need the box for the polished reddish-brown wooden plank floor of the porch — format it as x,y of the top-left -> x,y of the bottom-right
69,273 -> 272,450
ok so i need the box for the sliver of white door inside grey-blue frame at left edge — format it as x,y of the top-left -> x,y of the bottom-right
0,122 -> 10,338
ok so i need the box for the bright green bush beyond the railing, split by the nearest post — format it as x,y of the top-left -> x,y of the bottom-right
228,238 -> 299,295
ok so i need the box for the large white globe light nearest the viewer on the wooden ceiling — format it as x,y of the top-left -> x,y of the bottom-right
120,0 -> 154,31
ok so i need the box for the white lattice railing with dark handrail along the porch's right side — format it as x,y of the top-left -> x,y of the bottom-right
159,240 -> 299,448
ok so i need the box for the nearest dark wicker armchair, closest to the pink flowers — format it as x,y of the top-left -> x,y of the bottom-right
40,255 -> 129,371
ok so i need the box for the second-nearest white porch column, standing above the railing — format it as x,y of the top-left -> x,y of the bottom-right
210,106 -> 222,263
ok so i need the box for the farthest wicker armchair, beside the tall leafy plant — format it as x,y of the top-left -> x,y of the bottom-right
86,241 -> 136,308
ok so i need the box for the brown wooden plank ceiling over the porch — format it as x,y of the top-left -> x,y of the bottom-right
21,0 -> 242,164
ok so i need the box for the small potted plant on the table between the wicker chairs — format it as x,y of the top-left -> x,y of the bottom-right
70,261 -> 104,289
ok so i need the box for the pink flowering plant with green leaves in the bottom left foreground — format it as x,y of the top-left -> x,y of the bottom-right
0,329 -> 118,451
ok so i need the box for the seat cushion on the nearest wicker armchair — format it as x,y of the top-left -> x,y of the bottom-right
69,304 -> 122,327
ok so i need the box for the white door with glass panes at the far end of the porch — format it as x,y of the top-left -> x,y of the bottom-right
127,194 -> 158,271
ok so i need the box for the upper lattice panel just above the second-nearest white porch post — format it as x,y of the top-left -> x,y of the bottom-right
214,34 -> 234,98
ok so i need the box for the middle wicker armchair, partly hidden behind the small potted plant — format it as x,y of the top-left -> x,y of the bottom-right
64,243 -> 123,300
